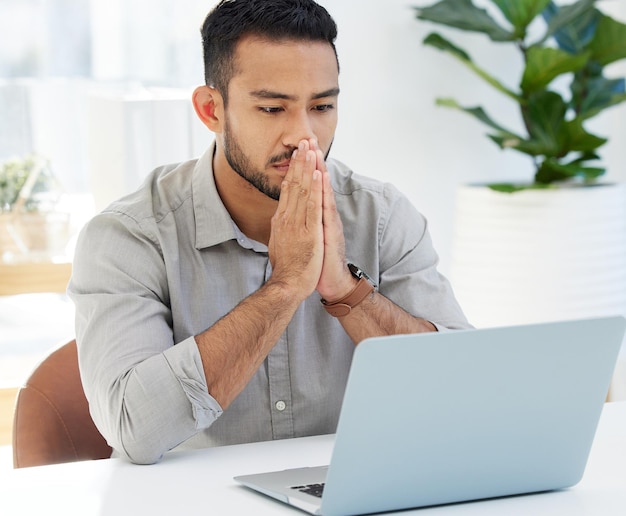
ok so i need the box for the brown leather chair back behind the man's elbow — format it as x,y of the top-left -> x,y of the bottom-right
13,340 -> 112,468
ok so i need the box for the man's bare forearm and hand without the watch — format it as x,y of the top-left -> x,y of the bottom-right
196,142 -> 323,409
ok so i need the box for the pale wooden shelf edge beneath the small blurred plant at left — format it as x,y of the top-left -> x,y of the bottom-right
0,262 -> 72,296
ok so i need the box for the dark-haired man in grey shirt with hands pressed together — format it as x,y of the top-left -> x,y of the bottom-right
69,0 -> 468,463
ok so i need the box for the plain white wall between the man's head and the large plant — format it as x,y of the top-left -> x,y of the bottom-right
320,0 -> 626,273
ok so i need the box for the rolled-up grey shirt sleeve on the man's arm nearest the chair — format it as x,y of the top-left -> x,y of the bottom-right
68,212 -> 222,463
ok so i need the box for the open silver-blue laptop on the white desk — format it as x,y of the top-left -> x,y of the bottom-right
235,317 -> 626,516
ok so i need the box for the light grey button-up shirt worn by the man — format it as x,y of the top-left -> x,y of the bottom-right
68,147 -> 469,463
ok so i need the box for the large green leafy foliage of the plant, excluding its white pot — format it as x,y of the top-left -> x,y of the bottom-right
415,0 -> 626,192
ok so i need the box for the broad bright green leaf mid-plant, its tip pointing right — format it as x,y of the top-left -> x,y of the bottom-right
520,46 -> 590,93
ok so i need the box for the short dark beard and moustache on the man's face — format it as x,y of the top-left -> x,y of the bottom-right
224,118 -> 332,201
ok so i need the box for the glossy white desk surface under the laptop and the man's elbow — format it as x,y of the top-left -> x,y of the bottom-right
0,403 -> 626,516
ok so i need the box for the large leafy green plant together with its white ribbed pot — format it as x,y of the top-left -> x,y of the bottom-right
415,0 -> 626,326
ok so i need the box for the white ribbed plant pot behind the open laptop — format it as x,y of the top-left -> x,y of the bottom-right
450,184 -> 626,327
